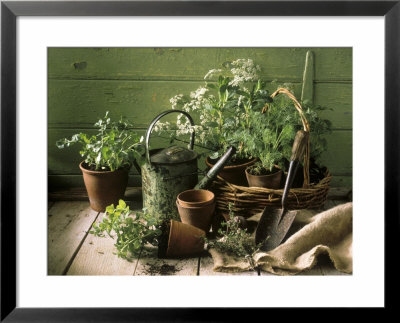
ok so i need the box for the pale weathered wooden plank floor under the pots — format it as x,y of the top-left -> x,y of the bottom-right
48,195 -> 352,276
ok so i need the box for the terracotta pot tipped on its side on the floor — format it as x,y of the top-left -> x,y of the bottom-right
166,220 -> 206,257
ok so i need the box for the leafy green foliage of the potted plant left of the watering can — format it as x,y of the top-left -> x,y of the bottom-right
56,111 -> 143,171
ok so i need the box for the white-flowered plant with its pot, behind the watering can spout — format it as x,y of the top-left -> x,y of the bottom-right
158,59 -> 271,185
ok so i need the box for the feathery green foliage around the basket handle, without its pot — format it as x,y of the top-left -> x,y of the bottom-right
236,86 -> 331,174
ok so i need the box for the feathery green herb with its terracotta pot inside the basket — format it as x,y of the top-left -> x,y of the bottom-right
244,87 -> 331,189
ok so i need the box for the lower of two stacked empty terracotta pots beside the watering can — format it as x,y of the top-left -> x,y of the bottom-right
176,200 -> 215,232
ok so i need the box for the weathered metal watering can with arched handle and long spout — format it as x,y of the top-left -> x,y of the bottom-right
141,110 -> 235,220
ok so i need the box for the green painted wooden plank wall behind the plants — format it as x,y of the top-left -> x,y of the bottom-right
48,48 -> 352,190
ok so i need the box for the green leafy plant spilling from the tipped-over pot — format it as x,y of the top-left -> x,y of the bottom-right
90,200 -> 161,259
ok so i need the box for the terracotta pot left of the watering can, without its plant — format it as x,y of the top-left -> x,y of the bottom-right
79,162 -> 129,212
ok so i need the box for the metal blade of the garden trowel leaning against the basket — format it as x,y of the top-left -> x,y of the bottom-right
255,207 -> 297,251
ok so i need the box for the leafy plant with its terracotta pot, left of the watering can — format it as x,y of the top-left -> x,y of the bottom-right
56,111 -> 142,212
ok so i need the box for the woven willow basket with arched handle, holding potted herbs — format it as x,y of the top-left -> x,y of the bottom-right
210,88 -> 331,217
